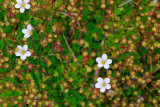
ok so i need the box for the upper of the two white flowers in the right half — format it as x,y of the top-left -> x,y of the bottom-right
96,54 -> 112,69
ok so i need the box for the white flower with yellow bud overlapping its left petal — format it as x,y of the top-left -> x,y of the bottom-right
15,45 -> 31,60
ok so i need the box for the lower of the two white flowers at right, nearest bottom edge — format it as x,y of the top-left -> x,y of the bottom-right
95,77 -> 111,92
